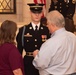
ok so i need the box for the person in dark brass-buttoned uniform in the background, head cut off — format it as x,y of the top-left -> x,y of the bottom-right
49,0 -> 75,32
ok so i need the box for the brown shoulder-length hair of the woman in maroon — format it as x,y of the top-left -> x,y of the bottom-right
0,20 -> 17,45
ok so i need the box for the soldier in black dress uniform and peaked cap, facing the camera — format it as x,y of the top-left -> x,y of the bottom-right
16,3 -> 50,75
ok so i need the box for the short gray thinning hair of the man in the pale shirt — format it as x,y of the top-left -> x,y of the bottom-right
46,10 -> 65,27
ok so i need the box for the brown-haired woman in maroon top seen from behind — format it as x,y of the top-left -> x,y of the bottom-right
0,20 -> 24,75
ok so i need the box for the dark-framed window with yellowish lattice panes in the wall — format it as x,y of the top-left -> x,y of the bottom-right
0,0 -> 16,14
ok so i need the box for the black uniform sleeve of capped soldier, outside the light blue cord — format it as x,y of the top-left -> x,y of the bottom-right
16,28 -> 23,54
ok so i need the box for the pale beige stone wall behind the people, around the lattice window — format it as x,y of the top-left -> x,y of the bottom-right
0,0 -> 76,27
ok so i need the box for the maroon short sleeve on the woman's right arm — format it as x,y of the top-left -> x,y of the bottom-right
9,47 -> 24,71
